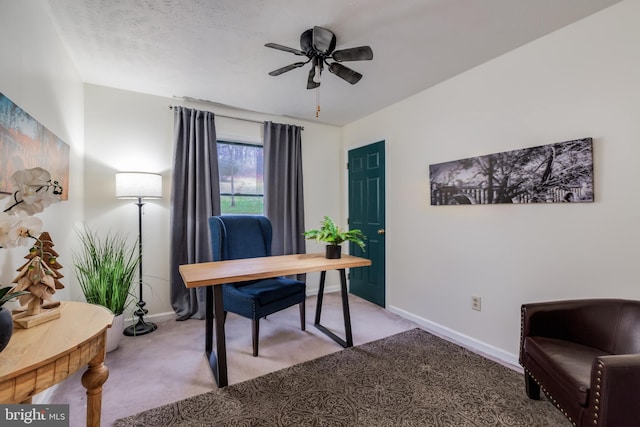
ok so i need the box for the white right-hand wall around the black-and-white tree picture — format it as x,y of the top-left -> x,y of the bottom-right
343,0 -> 640,364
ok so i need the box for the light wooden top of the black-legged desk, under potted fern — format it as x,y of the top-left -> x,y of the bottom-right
179,253 -> 371,288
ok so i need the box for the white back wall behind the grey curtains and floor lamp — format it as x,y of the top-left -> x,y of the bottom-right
85,85 -> 342,319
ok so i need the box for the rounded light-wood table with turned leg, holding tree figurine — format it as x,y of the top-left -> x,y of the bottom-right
0,302 -> 113,427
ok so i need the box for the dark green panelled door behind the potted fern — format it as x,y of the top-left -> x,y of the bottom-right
348,141 -> 385,307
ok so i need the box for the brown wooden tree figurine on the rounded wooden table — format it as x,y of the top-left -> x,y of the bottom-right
13,232 -> 64,327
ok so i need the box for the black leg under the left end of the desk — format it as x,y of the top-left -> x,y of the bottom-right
204,286 -> 229,387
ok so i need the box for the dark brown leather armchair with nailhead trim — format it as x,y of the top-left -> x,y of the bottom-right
520,299 -> 640,427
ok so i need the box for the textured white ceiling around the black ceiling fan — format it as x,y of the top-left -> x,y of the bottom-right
43,0 -> 619,125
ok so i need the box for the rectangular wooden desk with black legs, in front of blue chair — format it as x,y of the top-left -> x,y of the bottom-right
179,254 -> 371,387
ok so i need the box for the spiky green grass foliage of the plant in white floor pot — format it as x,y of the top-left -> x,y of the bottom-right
73,227 -> 140,316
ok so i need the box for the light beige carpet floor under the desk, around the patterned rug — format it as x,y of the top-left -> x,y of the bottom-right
47,293 -> 420,427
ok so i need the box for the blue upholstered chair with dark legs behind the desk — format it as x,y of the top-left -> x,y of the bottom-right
209,215 -> 306,357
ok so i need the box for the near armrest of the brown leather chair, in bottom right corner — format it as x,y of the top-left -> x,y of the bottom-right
588,354 -> 640,427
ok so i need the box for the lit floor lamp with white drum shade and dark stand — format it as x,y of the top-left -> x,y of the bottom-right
116,172 -> 162,336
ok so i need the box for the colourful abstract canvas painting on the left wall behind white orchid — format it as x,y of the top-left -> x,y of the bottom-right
0,93 -> 69,200
